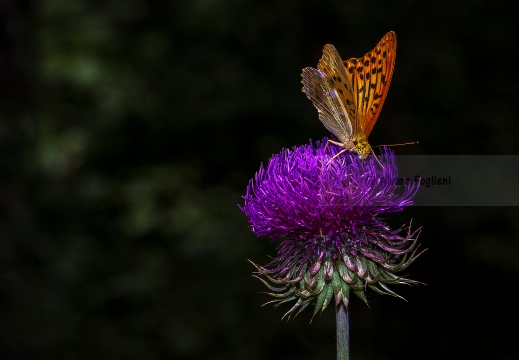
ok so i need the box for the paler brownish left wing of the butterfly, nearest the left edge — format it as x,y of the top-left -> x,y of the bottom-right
302,67 -> 352,143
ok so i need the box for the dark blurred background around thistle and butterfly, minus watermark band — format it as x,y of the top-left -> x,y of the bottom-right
0,0 -> 519,359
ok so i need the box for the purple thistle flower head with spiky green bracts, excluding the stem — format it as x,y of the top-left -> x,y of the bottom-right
242,139 -> 420,316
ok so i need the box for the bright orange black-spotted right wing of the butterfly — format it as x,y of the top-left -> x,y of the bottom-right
344,31 -> 396,137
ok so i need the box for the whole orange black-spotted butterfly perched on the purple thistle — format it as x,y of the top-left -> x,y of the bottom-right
301,31 -> 396,159
